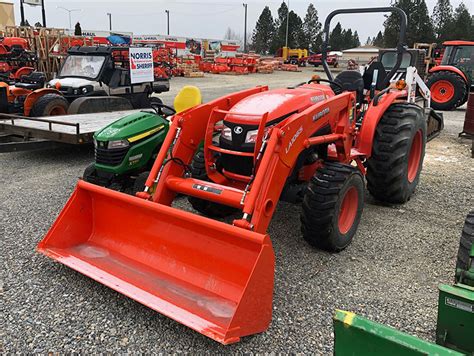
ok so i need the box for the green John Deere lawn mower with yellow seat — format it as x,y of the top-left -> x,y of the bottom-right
83,86 -> 201,195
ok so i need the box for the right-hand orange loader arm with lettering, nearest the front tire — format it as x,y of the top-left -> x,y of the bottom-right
241,92 -> 355,233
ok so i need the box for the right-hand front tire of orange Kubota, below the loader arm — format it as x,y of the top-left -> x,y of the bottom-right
301,162 -> 364,252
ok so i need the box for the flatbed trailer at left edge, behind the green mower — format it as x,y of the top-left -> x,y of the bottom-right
0,110 -> 139,153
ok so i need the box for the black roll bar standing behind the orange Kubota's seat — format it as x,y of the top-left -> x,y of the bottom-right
321,7 -> 407,85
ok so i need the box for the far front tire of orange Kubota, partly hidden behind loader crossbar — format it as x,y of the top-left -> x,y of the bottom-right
188,149 -> 237,218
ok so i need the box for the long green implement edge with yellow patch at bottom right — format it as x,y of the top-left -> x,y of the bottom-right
334,310 -> 463,356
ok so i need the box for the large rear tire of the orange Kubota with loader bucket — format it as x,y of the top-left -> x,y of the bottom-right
366,103 -> 426,204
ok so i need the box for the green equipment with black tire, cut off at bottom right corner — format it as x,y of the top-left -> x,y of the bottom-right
334,210 -> 474,356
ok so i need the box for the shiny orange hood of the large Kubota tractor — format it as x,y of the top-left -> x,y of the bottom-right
224,84 -> 334,125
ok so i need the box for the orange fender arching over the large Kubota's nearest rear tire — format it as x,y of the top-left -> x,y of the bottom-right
355,90 -> 407,158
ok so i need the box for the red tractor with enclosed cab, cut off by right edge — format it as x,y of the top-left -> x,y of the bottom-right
426,41 -> 474,110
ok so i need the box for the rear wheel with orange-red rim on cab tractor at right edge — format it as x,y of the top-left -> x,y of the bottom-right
426,70 -> 469,110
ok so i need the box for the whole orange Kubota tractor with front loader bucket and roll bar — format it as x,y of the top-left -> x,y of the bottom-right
38,7 -> 441,344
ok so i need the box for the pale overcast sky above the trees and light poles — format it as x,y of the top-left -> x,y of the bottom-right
8,0 -> 474,43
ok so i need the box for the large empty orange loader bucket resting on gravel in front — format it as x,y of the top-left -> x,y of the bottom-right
38,181 -> 274,344
